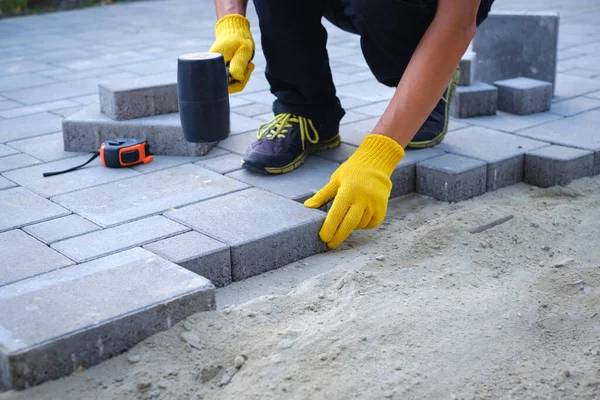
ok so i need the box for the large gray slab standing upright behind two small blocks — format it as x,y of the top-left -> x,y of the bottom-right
473,11 -> 559,92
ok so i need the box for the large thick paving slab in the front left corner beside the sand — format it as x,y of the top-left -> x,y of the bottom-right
0,249 -> 215,390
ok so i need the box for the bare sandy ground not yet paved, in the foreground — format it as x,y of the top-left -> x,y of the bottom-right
0,177 -> 600,400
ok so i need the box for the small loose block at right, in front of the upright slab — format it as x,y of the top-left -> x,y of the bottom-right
494,78 -> 552,115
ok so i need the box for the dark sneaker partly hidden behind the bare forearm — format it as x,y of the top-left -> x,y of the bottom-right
408,68 -> 460,149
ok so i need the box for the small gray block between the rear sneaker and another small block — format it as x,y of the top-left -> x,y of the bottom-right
450,81 -> 498,118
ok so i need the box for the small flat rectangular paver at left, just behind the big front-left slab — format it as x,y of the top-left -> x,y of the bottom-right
23,214 -> 100,244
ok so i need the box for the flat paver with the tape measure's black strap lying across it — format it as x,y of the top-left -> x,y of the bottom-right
3,155 -> 139,197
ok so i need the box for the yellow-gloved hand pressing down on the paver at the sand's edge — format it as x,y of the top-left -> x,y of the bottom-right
304,134 -> 404,249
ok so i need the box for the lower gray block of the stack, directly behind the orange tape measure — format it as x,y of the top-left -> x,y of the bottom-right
61,103 -> 216,156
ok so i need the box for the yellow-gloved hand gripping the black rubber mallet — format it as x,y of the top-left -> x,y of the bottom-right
209,14 -> 255,94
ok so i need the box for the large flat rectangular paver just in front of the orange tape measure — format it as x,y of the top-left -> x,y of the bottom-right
53,164 -> 248,227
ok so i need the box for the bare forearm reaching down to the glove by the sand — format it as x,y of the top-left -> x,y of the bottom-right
373,0 -> 480,147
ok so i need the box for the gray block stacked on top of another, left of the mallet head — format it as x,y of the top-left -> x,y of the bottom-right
99,73 -> 179,121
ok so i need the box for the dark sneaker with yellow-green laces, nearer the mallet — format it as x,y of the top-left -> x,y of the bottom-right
242,113 -> 341,174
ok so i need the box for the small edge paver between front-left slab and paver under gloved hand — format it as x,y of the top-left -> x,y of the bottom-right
144,231 -> 231,287
